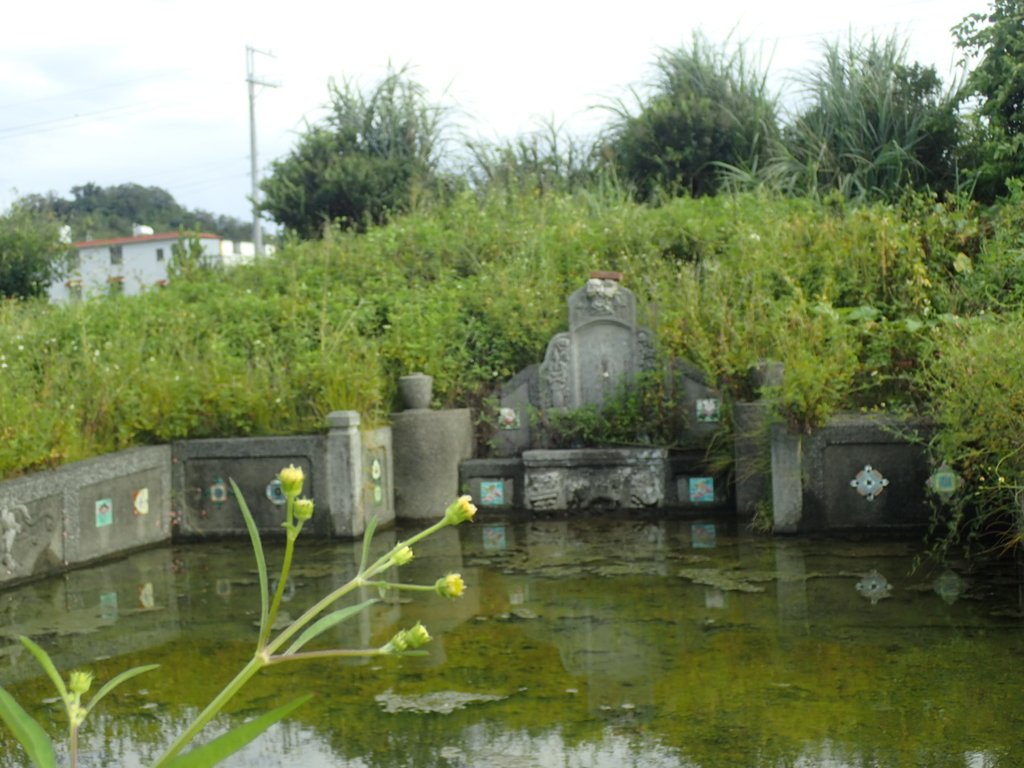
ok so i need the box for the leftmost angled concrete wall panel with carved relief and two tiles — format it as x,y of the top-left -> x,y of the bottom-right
0,445 -> 171,584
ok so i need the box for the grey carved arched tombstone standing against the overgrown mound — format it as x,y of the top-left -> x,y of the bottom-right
540,272 -> 654,411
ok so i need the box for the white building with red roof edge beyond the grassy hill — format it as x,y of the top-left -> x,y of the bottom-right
49,226 -> 273,301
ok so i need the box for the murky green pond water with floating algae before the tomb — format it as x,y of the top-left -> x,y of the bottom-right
0,518 -> 1024,768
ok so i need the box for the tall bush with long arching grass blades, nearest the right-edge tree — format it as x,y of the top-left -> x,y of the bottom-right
754,36 -> 958,201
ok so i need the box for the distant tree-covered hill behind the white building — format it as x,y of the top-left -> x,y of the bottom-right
24,182 -> 252,240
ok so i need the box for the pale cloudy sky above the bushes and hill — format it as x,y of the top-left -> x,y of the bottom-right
0,0 -> 988,228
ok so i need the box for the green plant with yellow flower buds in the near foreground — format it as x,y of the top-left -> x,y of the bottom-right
0,465 -> 476,768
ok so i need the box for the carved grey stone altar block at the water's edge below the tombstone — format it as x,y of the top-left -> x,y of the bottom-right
522,449 -> 668,510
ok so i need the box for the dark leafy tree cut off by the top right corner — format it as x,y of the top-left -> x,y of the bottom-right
952,0 -> 1024,202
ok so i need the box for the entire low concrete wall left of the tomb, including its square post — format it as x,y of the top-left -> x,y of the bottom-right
0,412 -> 395,586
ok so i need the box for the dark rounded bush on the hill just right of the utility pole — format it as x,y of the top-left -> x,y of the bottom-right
260,69 -> 444,238
